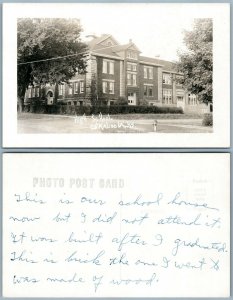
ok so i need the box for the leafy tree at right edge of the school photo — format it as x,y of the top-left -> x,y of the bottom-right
178,19 -> 213,103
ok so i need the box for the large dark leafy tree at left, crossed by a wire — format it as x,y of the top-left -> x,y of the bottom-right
17,18 -> 87,106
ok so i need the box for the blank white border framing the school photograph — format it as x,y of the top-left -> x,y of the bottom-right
3,3 -> 230,148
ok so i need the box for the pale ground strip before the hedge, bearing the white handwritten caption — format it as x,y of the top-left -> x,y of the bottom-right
18,113 -> 213,134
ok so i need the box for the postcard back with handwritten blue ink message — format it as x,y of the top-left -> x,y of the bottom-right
3,153 -> 230,299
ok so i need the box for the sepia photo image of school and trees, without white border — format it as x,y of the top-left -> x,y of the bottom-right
17,18 -> 213,133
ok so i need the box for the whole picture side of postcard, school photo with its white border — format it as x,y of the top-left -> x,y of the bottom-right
3,3 -> 230,147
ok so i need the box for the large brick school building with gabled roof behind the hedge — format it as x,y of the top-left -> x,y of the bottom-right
25,34 -> 210,113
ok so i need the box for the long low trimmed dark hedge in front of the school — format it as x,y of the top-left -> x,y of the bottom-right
24,104 -> 183,115
